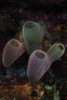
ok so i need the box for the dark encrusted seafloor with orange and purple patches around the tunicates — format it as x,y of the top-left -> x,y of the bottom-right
0,0 -> 67,100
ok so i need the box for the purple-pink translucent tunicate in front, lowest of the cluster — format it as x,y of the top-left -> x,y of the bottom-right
27,50 -> 51,82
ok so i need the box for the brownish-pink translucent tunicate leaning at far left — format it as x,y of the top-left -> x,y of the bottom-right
2,39 -> 26,67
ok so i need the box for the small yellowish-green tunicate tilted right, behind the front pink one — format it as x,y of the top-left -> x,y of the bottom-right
47,43 -> 65,62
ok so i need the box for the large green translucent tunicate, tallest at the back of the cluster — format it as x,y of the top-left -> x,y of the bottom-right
22,21 -> 49,54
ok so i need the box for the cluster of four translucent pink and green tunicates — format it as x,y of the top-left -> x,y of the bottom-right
2,21 -> 65,82
